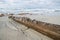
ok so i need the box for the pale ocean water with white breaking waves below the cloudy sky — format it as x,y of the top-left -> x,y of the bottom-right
0,9 -> 60,14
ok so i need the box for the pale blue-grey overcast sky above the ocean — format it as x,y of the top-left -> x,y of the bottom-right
0,0 -> 60,9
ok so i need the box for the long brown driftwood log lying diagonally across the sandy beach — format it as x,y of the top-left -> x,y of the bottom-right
11,17 -> 60,40
